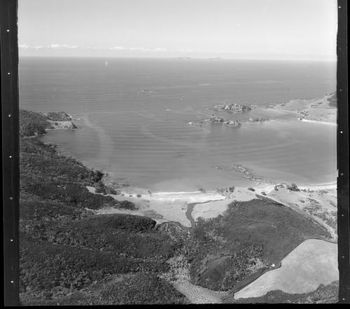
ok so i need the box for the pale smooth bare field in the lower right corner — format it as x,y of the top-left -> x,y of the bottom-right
234,239 -> 339,299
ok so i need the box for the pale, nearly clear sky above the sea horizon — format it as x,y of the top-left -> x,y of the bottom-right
18,0 -> 337,61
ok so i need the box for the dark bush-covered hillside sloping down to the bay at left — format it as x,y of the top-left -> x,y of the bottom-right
20,111 -> 185,305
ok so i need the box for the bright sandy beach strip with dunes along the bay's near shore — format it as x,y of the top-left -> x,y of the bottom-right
87,180 -> 337,233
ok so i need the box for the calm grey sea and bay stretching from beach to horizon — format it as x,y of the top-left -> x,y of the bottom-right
19,58 -> 336,191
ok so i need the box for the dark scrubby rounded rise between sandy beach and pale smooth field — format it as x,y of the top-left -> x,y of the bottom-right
189,199 -> 329,290
